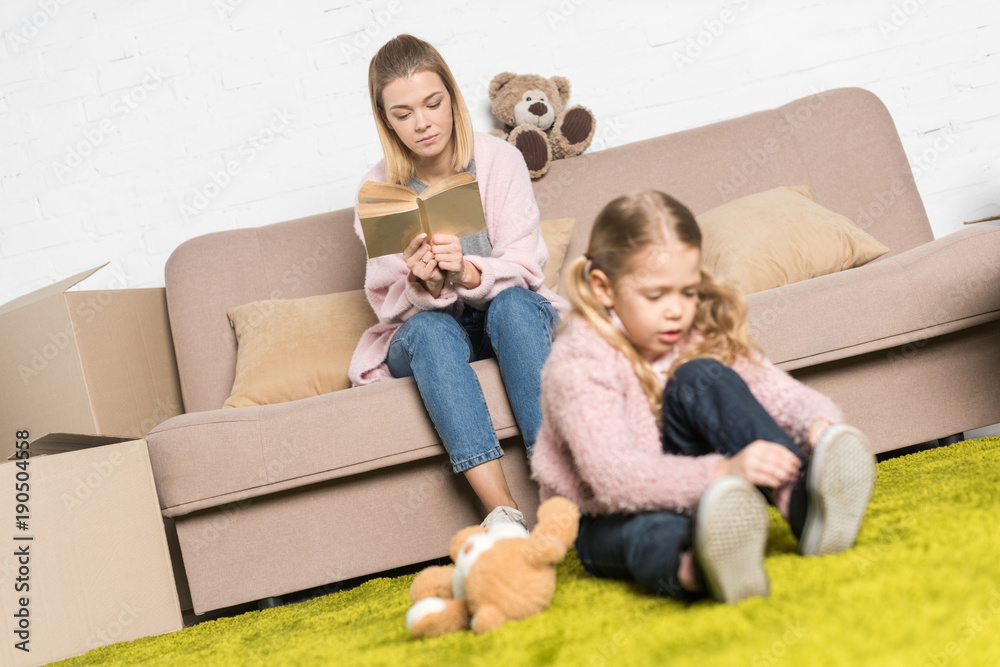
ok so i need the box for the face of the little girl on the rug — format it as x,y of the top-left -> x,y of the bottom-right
590,241 -> 701,361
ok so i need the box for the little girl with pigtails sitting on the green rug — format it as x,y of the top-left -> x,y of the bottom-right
531,191 -> 875,602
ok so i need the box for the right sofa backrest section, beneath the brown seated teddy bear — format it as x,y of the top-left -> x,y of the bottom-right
535,88 -> 934,291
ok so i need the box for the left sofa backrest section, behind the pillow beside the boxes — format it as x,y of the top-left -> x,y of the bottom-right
164,209 -> 365,412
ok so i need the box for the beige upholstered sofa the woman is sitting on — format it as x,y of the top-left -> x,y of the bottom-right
148,89 -> 1000,613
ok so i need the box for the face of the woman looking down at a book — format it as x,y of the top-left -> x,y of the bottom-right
382,72 -> 453,162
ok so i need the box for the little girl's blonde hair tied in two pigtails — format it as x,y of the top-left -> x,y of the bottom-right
566,190 -> 759,419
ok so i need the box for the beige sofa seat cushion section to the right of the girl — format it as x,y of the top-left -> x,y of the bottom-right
747,225 -> 1000,370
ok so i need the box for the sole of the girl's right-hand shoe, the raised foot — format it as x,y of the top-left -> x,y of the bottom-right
799,425 -> 875,556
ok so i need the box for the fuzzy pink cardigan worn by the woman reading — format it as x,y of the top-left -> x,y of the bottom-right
348,133 -> 569,386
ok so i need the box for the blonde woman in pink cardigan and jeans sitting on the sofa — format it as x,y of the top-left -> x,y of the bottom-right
349,35 -> 568,527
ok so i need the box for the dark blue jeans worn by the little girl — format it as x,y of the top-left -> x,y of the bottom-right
576,359 -> 806,599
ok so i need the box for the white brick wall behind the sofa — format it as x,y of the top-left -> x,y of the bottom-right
0,0 -> 1000,303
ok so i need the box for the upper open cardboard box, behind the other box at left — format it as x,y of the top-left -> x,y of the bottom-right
0,267 -> 184,460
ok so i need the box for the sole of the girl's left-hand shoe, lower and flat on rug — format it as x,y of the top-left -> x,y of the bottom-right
694,477 -> 770,604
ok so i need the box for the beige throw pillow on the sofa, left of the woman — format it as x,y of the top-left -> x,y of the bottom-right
223,290 -> 378,408
